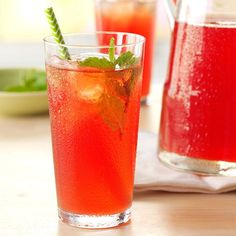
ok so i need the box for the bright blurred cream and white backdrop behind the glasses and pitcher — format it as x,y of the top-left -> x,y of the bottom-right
0,0 -> 170,83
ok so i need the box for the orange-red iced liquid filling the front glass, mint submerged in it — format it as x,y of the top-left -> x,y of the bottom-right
47,58 -> 141,215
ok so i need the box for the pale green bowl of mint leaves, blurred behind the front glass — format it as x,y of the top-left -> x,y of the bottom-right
0,68 -> 48,116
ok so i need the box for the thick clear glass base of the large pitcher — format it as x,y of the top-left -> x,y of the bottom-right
159,151 -> 236,176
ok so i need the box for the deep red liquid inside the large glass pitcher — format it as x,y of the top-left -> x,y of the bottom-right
160,23 -> 236,164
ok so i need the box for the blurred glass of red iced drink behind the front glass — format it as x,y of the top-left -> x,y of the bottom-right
96,0 -> 157,101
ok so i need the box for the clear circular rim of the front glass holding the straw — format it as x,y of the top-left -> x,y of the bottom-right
43,31 -> 146,49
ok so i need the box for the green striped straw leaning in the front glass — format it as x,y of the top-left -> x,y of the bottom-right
45,7 -> 70,60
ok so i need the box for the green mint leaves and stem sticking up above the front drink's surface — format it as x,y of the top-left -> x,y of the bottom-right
79,37 -> 138,69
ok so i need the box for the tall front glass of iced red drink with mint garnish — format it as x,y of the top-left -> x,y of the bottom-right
44,32 -> 145,228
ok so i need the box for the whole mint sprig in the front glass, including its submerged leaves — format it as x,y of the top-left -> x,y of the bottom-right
78,38 -> 140,137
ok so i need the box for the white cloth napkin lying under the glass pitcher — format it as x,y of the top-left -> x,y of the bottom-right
135,131 -> 236,193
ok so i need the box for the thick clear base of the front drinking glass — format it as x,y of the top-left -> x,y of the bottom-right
58,208 -> 131,229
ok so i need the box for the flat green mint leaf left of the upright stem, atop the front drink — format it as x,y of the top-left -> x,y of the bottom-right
79,57 -> 114,69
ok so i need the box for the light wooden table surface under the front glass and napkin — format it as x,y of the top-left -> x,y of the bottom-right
0,85 -> 236,236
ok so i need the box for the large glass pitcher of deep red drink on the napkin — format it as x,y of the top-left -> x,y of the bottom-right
159,0 -> 236,176
